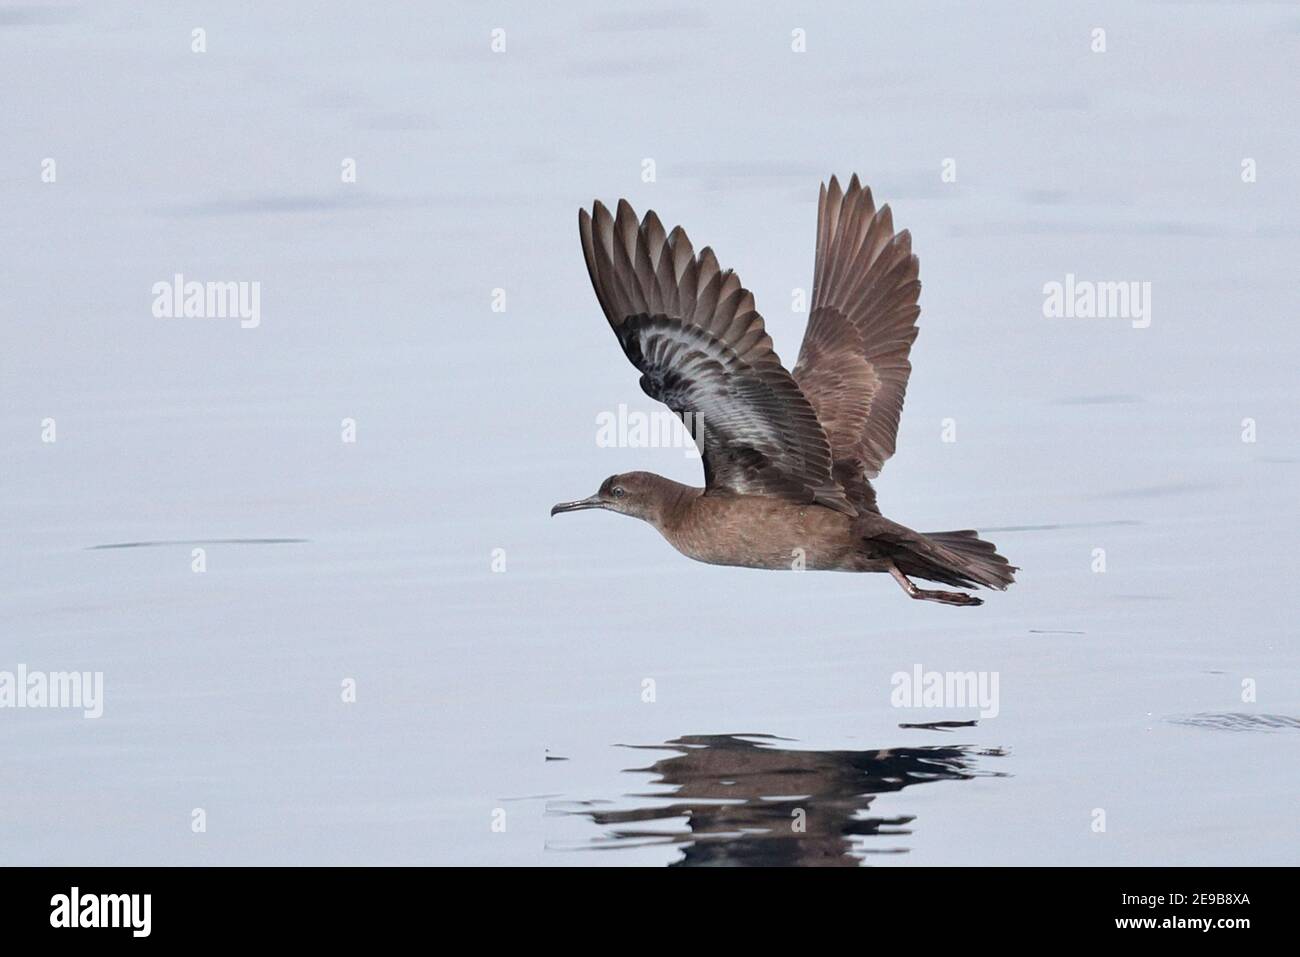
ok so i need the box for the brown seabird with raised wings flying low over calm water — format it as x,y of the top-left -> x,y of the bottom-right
551,174 -> 1018,606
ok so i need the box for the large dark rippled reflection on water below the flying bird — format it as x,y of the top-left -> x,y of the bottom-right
564,735 -> 1004,867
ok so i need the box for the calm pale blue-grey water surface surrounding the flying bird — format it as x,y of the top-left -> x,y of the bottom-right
0,3 -> 1300,865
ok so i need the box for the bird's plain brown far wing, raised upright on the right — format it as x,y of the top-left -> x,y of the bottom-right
794,176 -> 920,510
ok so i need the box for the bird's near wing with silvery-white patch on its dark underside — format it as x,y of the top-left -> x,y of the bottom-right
579,200 -> 855,515
